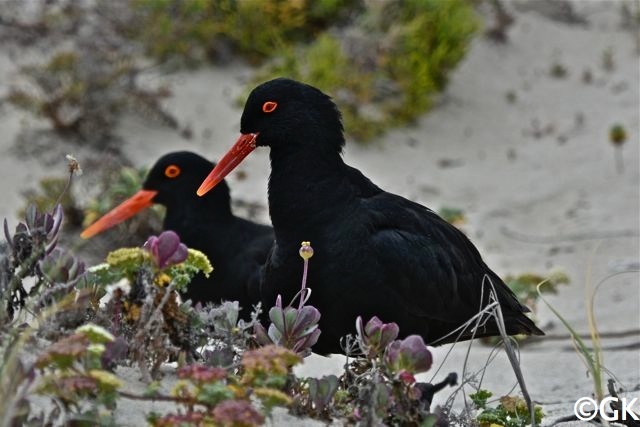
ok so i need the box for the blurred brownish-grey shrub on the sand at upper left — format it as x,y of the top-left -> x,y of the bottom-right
7,46 -> 176,146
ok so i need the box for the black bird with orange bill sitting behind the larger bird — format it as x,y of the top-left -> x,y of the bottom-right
82,151 -> 273,318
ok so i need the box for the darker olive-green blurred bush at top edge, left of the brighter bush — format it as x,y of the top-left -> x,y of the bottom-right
132,0 -> 357,64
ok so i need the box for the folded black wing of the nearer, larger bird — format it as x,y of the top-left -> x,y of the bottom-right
361,192 -> 525,321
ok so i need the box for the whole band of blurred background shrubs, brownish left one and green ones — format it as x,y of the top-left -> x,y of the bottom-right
0,0 -> 479,142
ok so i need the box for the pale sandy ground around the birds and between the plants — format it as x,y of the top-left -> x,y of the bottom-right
0,1 -> 640,425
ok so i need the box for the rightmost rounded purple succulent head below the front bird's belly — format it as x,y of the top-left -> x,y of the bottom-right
385,335 -> 433,374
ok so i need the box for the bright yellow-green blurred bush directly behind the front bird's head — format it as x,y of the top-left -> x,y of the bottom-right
253,0 -> 478,140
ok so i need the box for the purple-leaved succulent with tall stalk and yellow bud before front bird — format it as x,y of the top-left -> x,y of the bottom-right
254,242 -> 320,357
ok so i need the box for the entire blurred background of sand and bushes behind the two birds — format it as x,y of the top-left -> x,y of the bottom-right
0,0 -> 640,418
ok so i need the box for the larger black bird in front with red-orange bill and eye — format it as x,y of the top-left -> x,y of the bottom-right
198,78 -> 543,353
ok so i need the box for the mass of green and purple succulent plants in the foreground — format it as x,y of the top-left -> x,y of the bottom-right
0,200 -> 442,426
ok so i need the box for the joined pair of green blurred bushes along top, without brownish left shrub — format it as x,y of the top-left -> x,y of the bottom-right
133,0 -> 478,141
